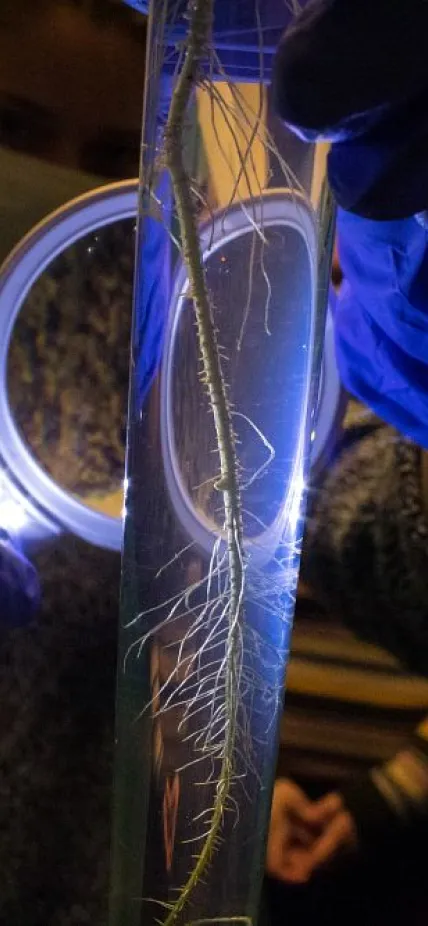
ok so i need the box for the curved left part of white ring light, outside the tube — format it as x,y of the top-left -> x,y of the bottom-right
0,180 -> 138,550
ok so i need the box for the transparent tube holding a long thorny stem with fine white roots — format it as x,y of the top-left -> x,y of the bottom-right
110,0 -> 333,926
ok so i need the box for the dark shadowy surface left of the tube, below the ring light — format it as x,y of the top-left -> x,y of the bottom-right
0,538 -> 120,926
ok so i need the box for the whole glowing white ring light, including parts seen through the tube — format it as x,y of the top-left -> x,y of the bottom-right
0,180 -> 341,550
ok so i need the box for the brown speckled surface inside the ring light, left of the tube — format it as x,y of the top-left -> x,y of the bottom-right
8,219 -> 134,497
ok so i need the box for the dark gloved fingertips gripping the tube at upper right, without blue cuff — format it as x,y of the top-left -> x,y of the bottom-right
273,0 -> 428,219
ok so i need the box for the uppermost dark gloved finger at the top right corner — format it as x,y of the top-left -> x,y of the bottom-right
274,0 -> 428,138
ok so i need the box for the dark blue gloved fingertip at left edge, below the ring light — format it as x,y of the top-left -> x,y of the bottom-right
0,530 -> 40,631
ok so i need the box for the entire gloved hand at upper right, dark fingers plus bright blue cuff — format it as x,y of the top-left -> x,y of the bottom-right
274,0 -> 428,447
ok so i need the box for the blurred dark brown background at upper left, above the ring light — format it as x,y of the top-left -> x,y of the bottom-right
0,0 -> 145,259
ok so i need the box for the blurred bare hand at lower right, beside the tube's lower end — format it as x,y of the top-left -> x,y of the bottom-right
266,779 -> 357,884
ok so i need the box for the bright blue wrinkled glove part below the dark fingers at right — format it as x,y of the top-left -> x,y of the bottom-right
336,210 -> 428,448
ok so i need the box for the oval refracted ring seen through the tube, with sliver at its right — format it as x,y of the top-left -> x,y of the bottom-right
161,189 -> 341,558
